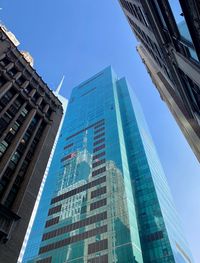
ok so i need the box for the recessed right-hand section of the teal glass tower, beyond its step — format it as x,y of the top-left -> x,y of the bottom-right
118,79 -> 193,263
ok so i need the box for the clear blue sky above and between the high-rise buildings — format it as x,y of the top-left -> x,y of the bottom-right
0,0 -> 200,263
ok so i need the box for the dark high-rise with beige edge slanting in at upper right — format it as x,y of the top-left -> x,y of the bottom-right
119,0 -> 200,161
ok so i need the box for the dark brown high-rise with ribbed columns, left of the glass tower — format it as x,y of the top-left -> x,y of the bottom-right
0,25 -> 63,263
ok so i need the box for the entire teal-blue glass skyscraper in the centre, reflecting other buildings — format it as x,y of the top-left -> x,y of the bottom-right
23,67 -> 192,263
